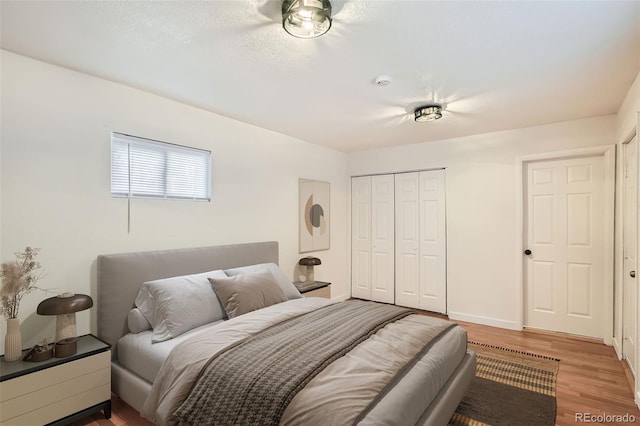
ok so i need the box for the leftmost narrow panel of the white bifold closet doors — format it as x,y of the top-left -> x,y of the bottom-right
351,176 -> 372,299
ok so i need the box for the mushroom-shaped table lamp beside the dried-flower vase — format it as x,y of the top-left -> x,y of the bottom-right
36,293 -> 93,358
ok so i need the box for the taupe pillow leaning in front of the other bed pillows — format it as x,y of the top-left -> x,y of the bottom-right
209,270 -> 287,318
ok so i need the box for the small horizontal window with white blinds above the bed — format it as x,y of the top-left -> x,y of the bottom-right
111,132 -> 211,201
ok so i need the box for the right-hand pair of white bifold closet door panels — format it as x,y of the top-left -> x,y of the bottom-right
395,170 -> 447,313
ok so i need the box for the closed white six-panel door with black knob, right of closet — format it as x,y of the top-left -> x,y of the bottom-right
524,156 -> 609,338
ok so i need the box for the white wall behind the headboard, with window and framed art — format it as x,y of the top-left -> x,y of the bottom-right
0,51 -> 349,353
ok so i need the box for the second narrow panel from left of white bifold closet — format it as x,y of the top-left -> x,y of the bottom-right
371,175 -> 395,303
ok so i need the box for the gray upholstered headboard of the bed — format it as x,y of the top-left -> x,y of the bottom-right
97,241 -> 278,360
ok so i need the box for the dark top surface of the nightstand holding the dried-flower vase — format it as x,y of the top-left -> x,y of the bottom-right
0,334 -> 111,382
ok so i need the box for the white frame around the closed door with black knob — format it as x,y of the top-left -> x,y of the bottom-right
515,145 -> 616,346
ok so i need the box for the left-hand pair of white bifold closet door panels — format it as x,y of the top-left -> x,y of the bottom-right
351,175 -> 395,303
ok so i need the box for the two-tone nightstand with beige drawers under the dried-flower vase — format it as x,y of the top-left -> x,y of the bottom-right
0,334 -> 111,426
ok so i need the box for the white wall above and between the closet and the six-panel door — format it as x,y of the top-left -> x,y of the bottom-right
348,115 -> 616,329
